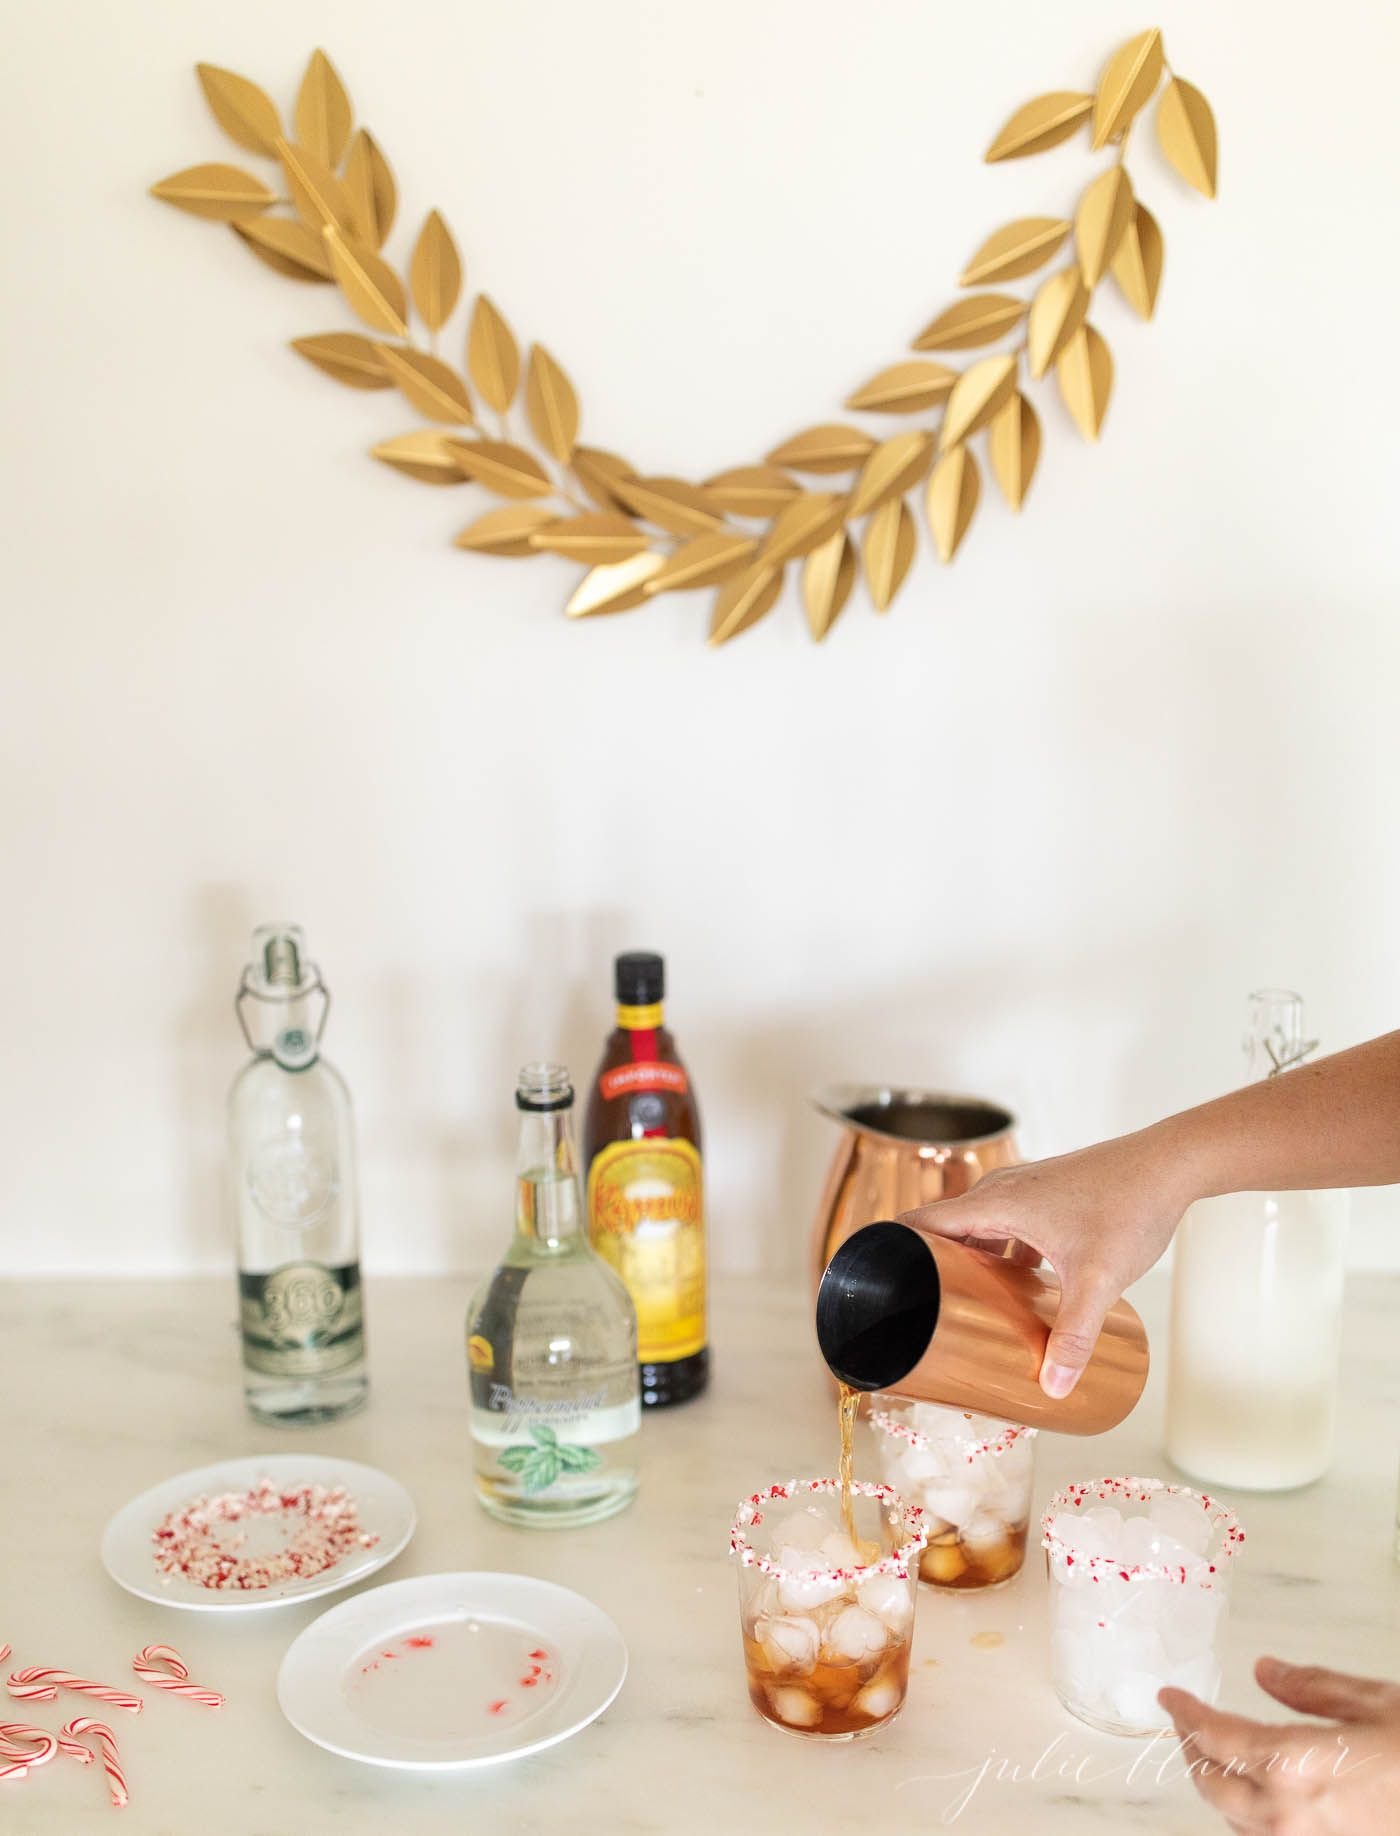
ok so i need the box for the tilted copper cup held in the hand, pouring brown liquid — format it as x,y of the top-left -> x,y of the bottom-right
817,1221 -> 1147,1434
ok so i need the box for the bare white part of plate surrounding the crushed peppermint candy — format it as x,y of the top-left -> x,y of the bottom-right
103,1454 -> 418,1612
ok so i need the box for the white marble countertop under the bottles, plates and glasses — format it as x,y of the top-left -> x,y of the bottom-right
0,1276 -> 1400,1836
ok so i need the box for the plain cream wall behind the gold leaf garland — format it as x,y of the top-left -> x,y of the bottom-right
0,0 -> 1400,1274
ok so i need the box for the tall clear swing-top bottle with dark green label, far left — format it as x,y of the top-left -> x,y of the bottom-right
229,924 -> 369,1423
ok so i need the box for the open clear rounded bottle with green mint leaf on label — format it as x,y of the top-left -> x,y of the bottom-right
466,1065 -> 640,1526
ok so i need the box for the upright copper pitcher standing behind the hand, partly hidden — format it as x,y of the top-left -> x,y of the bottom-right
811,1083 -> 1020,1285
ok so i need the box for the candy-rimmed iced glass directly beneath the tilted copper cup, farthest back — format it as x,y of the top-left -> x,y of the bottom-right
870,1403 -> 1037,1588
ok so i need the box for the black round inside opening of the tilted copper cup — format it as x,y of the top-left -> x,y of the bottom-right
817,1223 -> 939,1390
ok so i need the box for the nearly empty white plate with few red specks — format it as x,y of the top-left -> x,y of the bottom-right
277,1573 -> 628,1772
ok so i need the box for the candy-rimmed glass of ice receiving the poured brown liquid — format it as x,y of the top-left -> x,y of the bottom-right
728,1480 -> 925,1741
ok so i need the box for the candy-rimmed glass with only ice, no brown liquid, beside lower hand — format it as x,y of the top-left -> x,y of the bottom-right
1040,1478 -> 1244,1735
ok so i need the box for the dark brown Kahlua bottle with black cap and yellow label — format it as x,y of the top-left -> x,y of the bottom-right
583,951 -> 710,1408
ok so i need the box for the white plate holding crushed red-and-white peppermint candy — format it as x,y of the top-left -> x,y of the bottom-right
103,1454 -> 417,1612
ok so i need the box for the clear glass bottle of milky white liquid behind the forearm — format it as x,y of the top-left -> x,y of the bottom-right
1167,988 -> 1349,1491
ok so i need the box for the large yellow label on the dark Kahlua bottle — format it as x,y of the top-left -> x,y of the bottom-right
589,1138 -> 705,1364
